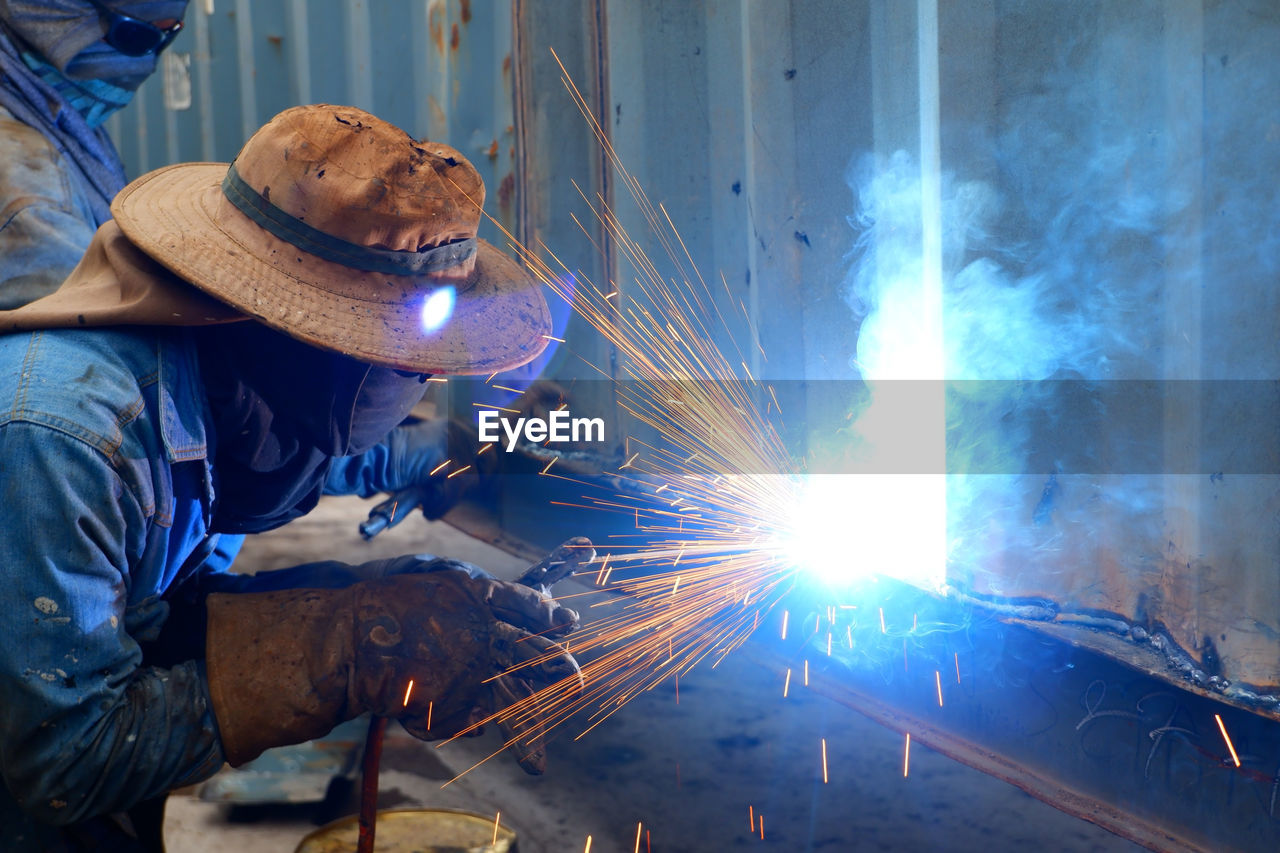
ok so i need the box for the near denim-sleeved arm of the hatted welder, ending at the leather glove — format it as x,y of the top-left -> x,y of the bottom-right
0,423 -> 223,824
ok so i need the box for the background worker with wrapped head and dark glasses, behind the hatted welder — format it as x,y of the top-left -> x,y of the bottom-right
0,0 -> 187,309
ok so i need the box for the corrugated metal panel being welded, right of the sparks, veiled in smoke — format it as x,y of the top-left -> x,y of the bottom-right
521,0 -> 1280,712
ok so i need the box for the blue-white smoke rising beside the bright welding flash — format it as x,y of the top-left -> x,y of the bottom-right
829,24 -> 1239,594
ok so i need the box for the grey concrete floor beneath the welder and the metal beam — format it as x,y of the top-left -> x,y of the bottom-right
165,498 -> 1140,853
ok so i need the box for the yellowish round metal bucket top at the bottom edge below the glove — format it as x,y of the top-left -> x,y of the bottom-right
294,808 -> 516,853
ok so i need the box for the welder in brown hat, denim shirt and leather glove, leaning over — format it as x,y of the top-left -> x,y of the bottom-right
0,105 -> 577,850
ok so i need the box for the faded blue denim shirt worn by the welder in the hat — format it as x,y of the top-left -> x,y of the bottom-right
0,320 -> 404,850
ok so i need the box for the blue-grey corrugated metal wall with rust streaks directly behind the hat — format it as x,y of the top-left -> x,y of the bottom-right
109,0 -> 516,240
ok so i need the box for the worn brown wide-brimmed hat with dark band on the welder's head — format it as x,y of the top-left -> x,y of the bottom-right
111,104 -> 550,374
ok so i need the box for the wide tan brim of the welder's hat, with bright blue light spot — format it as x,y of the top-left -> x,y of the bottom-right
111,163 -> 552,375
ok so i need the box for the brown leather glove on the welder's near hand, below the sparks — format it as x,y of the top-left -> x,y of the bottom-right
205,571 -> 581,774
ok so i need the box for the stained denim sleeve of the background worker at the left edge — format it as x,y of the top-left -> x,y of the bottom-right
0,108 -> 101,309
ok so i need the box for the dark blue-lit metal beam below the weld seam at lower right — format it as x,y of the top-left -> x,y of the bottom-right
745,578 -> 1280,853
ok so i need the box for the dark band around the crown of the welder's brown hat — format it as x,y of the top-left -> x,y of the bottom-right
223,163 -> 476,275
